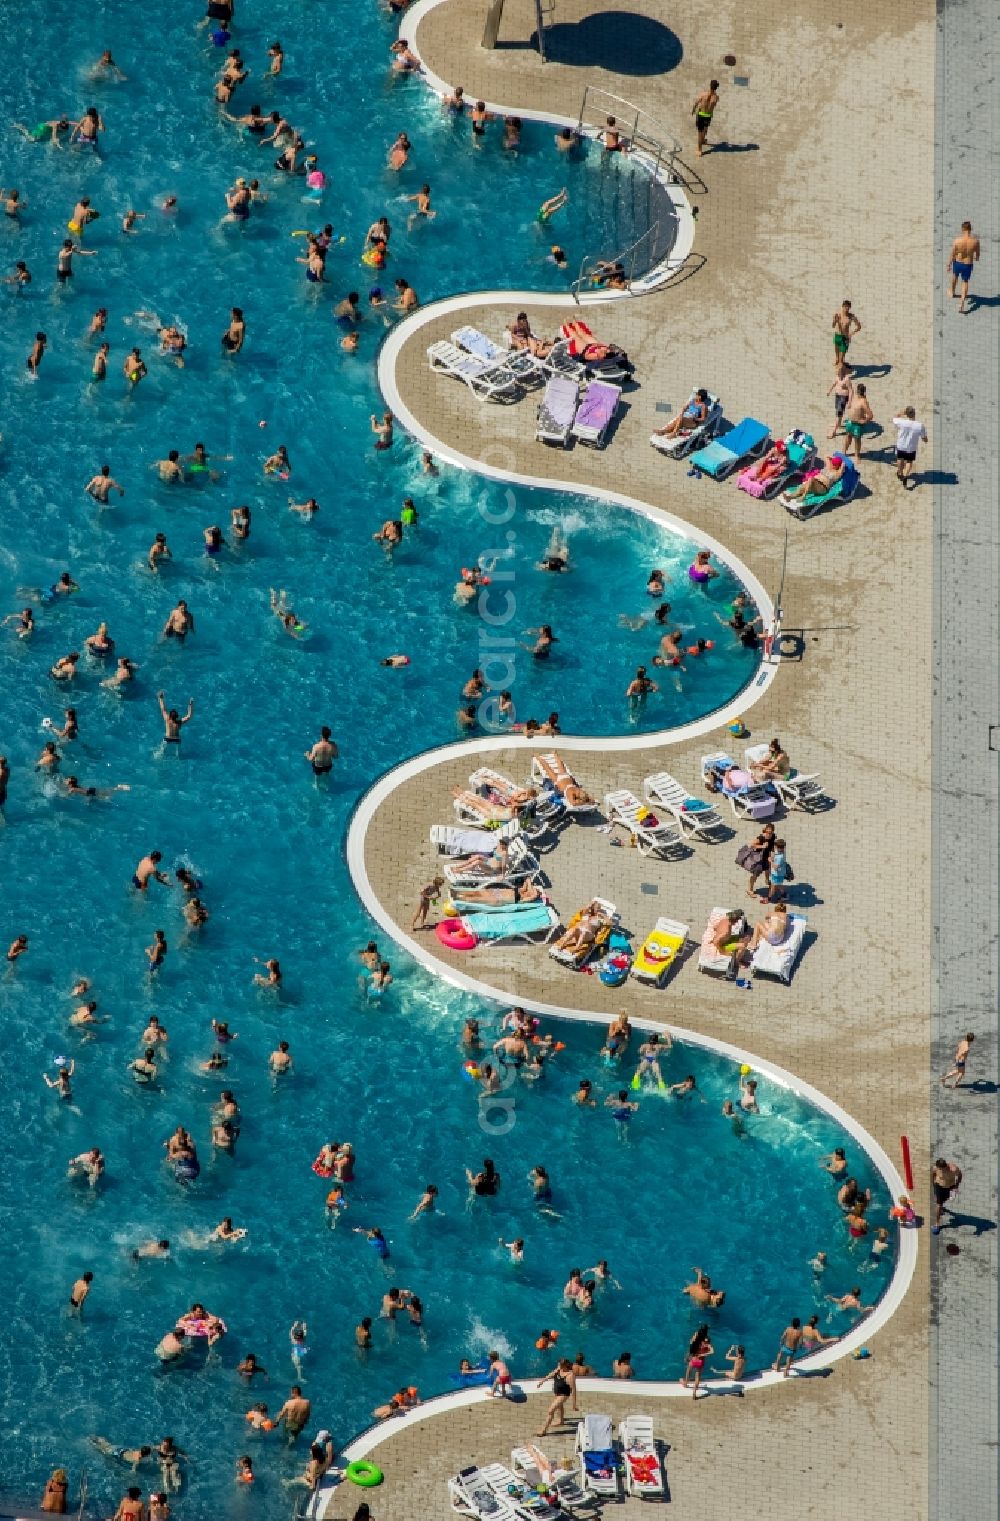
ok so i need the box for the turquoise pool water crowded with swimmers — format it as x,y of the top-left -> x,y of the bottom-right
0,0 -> 883,1515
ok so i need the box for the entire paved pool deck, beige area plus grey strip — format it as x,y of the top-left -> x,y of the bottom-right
327,0 -> 1000,1521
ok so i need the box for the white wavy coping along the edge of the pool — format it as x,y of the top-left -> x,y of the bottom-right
307,14 -> 918,1521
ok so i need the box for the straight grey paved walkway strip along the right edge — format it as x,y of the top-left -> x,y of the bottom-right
930,0 -> 1000,1521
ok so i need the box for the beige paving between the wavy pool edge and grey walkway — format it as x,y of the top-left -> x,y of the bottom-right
345,0 -> 935,1521
